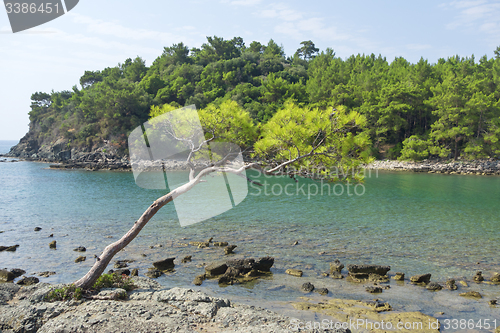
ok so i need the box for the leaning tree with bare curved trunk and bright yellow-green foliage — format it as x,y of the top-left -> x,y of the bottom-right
75,101 -> 371,289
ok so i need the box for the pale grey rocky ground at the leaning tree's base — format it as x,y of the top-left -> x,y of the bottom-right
0,277 -> 350,333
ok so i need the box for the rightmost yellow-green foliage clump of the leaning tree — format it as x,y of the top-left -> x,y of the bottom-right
254,101 -> 371,180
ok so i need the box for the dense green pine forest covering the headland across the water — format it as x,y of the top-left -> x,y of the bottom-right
26,36 -> 500,160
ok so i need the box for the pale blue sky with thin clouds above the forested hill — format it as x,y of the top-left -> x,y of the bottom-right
0,0 -> 500,140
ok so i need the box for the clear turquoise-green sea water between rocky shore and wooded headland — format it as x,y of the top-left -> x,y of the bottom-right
0,153 -> 500,326
